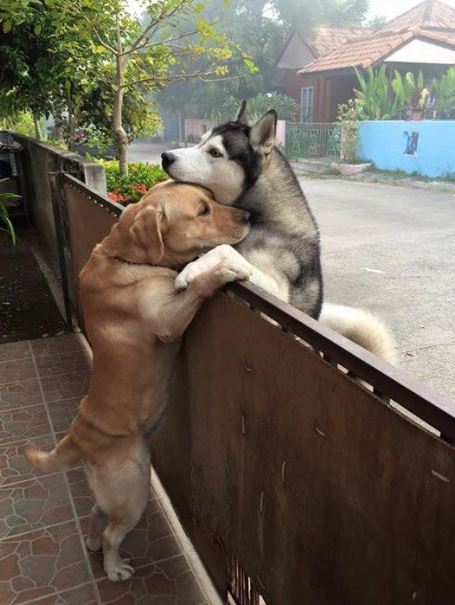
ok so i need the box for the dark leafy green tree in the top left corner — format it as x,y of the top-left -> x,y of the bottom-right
0,0 -> 104,144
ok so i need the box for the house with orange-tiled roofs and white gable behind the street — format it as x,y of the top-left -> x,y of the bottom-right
278,0 -> 455,122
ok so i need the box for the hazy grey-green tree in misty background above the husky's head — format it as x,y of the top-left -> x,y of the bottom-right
159,0 -> 368,119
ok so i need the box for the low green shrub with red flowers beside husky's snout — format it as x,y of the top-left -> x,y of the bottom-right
96,159 -> 168,204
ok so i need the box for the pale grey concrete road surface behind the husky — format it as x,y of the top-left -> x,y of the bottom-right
301,179 -> 455,407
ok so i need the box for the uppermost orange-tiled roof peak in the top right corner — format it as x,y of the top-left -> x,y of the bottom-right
380,0 -> 455,33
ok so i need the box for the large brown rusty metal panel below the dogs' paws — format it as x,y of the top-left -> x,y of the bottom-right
176,296 -> 455,605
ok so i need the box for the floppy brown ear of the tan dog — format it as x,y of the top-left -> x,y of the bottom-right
130,206 -> 164,263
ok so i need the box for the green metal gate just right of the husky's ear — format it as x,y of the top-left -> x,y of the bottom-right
285,122 -> 341,161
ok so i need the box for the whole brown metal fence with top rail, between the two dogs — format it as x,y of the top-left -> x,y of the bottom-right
61,176 -> 455,605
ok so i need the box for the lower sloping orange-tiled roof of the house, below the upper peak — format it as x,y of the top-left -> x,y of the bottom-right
298,29 -> 455,74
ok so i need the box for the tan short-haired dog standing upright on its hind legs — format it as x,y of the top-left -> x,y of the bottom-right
25,181 -> 249,581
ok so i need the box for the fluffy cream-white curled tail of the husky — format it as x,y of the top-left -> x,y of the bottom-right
319,303 -> 396,363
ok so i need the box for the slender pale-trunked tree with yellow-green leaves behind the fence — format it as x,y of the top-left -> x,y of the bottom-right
47,0 -> 244,174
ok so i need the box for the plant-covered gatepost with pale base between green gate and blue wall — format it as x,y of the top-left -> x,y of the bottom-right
331,99 -> 371,176
